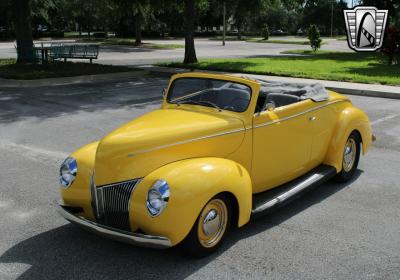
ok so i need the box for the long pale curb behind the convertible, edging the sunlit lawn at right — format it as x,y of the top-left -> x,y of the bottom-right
140,66 -> 400,99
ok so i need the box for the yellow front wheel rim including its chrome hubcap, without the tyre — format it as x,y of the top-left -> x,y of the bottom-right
197,199 -> 228,248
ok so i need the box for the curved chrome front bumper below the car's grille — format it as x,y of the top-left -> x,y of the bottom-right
57,202 -> 172,249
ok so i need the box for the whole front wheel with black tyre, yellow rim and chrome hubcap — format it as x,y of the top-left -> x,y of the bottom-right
182,195 -> 232,257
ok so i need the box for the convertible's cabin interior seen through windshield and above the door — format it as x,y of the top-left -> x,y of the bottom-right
168,78 -> 329,113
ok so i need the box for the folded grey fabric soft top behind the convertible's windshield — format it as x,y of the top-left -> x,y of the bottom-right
256,79 -> 329,102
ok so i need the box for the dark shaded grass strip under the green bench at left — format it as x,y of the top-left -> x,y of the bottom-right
0,59 -> 135,80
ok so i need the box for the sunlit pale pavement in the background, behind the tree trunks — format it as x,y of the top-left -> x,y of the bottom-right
0,37 -> 350,65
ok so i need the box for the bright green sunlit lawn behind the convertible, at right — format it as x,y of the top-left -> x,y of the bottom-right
163,50 -> 400,85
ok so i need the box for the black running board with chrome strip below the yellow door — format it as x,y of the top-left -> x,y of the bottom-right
252,165 -> 336,218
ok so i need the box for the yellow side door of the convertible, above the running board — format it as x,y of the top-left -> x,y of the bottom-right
252,100 -> 314,193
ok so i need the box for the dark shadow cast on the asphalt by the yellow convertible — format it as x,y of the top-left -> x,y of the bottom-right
0,170 -> 362,279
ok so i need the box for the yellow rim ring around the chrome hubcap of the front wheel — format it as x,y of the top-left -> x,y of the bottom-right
197,199 -> 228,248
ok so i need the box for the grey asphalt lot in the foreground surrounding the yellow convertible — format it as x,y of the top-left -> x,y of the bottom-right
0,77 -> 400,279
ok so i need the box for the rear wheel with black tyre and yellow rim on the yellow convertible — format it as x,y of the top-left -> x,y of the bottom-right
335,131 -> 361,182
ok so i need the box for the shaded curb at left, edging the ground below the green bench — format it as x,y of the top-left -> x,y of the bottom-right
0,70 -> 150,88
